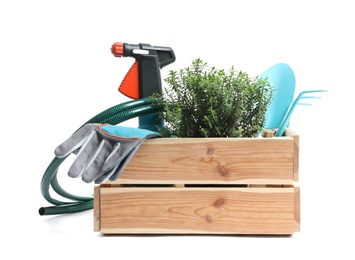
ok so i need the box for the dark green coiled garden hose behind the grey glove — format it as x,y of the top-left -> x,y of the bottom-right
38,98 -> 162,215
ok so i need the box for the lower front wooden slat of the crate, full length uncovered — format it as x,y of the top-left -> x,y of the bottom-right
100,187 -> 295,234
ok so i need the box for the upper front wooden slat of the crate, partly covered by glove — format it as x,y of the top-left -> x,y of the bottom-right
108,136 -> 298,184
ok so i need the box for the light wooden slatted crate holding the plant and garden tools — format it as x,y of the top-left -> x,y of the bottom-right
94,129 -> 300,235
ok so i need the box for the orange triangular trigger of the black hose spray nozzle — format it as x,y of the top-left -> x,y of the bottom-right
118,61 -> 139,99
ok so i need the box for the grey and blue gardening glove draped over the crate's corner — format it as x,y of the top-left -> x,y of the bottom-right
54,124 -> 161,184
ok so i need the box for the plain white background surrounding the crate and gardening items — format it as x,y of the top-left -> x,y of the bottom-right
0,0 -> 355,259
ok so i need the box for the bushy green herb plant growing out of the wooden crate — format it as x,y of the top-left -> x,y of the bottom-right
153,59 -> 273,137
